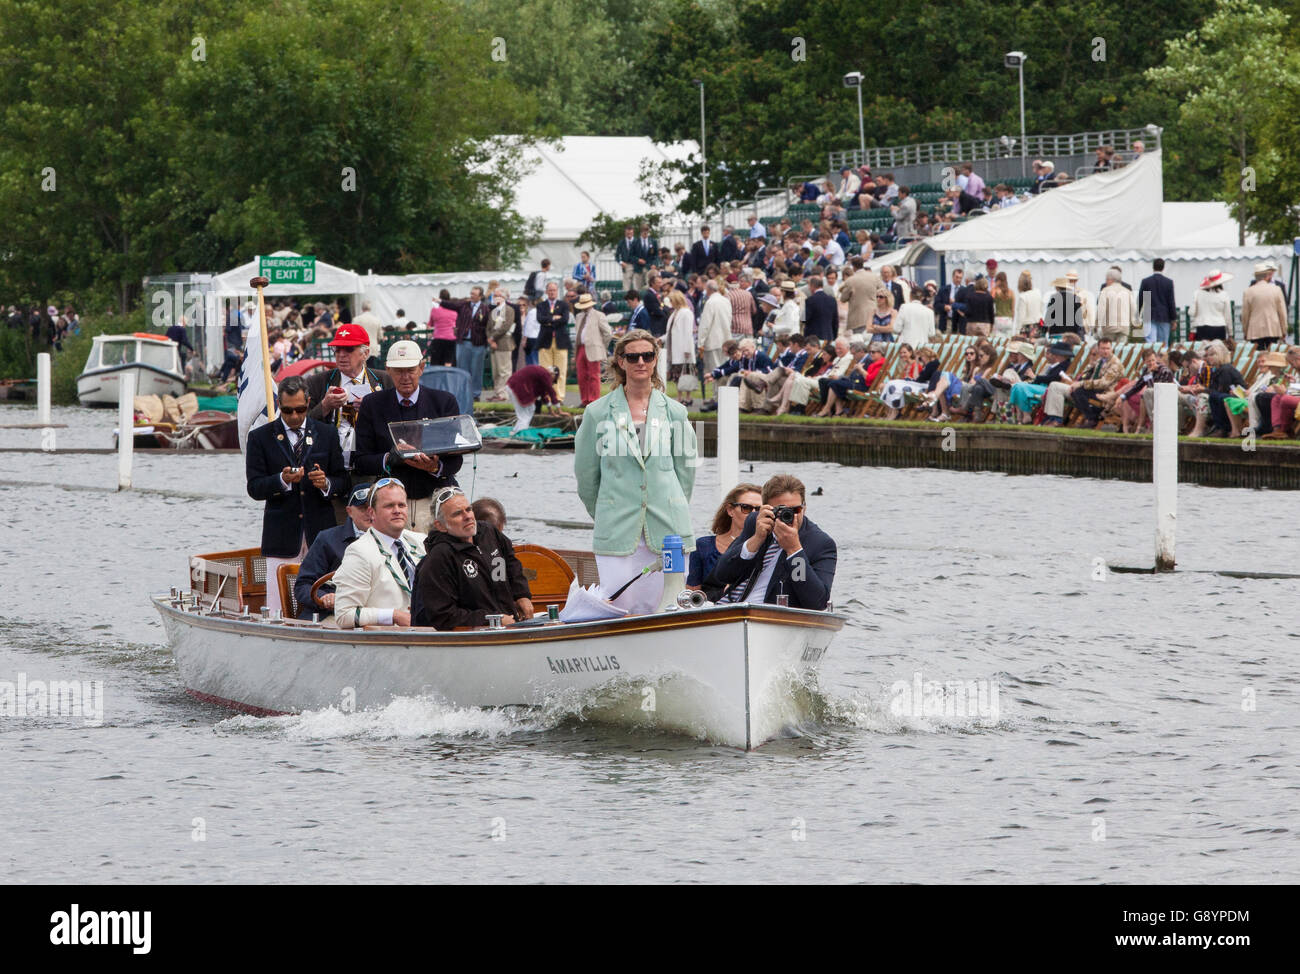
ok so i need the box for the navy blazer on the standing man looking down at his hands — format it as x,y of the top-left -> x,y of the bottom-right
244,417 -> 348,553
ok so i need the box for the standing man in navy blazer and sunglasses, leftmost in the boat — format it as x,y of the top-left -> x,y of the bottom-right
244,376 -> 348,611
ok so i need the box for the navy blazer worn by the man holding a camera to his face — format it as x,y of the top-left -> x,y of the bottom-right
705,511 -> 839,610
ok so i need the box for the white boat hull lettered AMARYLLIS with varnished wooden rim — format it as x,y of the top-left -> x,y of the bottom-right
153,597 -> 844,749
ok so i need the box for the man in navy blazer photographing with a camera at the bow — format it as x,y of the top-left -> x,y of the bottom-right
705,473 -> 839,610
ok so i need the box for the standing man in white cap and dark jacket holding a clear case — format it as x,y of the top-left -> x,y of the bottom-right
352,341 -> 464,534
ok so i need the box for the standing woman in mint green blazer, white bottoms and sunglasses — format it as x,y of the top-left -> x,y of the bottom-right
573,329 -> 698,614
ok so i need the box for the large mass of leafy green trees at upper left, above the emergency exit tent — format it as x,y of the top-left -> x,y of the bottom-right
0,0 -> 536,308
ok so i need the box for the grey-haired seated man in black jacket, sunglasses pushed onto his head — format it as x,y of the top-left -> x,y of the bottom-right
411,489 -> 533,631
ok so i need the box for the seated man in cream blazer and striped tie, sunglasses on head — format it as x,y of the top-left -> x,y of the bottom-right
334,477 -> 424,629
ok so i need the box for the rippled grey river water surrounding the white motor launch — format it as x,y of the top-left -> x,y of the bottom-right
0,407 -> 1300,883
